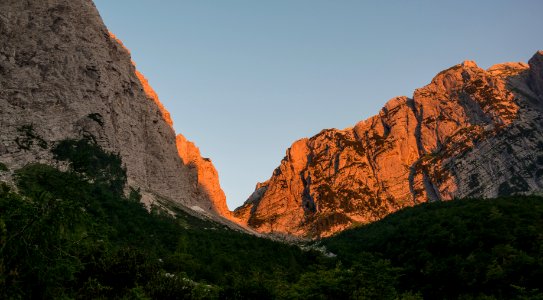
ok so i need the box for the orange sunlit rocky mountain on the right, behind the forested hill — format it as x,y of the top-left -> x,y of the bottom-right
234,51 -> 543,237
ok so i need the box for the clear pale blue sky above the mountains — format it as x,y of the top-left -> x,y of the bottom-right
95,0 -> 543,209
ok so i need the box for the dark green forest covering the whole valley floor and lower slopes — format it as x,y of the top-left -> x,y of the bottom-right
0,138 -> 543,299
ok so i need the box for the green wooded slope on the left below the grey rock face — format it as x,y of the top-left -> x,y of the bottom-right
0,139 -> 331,299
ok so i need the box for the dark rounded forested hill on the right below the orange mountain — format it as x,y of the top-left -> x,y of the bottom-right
323,196 -> 543,299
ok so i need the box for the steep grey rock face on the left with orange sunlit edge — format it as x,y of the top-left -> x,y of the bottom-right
0,0 -> 230,215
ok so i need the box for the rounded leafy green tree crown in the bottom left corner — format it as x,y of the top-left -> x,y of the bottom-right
0,178 -> 88,298
